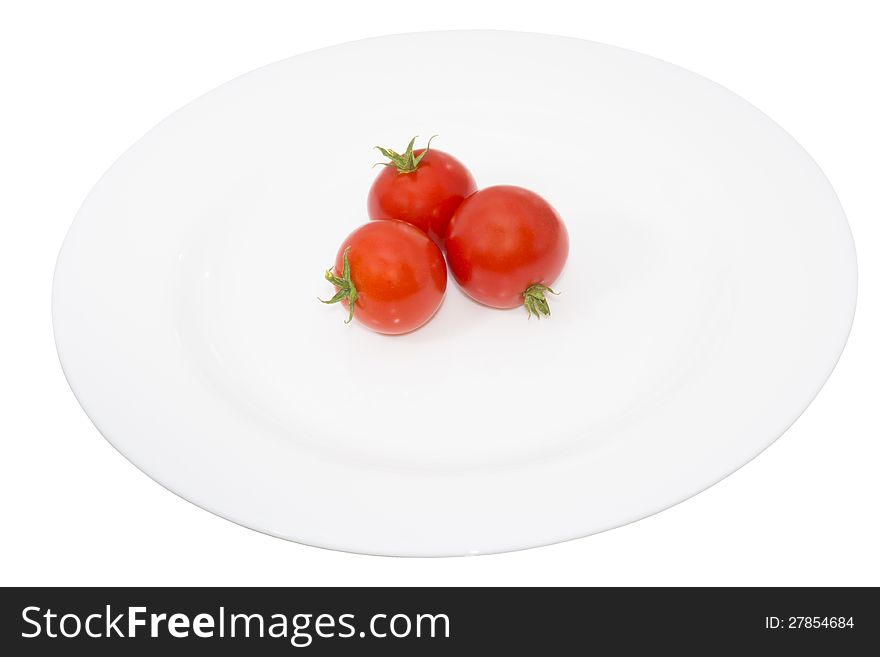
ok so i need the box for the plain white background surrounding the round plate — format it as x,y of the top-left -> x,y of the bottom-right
0,0 -> 880,585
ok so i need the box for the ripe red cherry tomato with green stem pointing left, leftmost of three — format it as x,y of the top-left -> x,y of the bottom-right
321,221 -> 446,335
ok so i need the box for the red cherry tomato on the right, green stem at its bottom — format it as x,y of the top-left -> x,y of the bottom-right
446,185 -> 568,318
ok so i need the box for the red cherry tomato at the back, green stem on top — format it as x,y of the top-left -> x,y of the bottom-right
367,137 -> 477,247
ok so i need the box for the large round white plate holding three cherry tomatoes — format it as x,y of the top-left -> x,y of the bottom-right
53,32 -> 856,555
